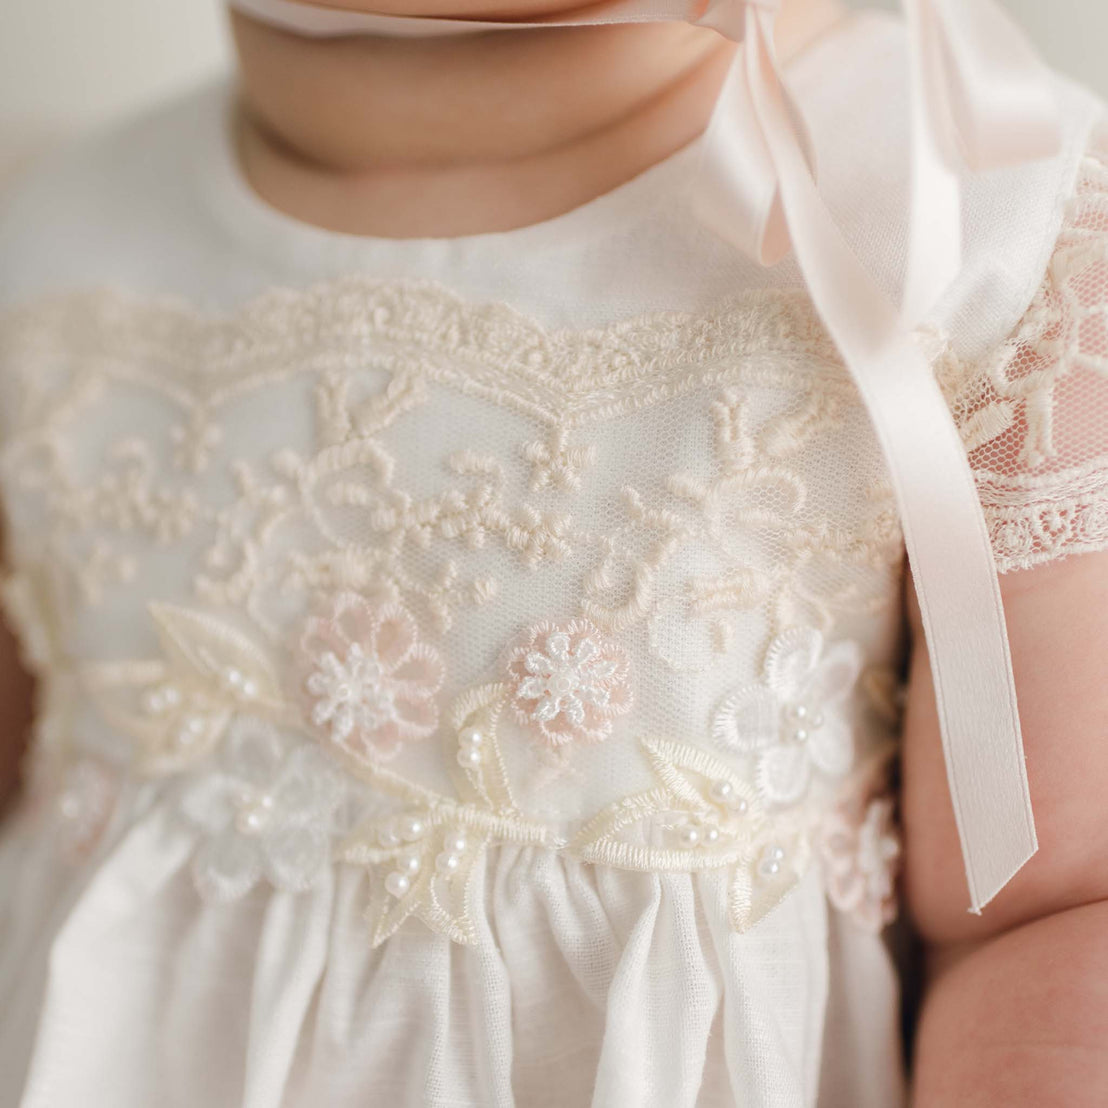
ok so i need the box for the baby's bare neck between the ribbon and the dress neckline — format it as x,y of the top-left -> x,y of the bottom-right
235,0 -> 842,238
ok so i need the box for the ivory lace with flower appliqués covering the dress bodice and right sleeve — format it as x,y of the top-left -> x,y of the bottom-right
0,203 -> 1108,942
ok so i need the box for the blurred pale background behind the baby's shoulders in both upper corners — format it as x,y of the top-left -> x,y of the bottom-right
0,0 -> 1108,181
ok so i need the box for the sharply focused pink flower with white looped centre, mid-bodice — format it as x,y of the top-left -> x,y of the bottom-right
507,619 -> 632,747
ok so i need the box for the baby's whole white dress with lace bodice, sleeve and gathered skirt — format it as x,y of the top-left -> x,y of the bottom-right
0,10 -> 1108,1108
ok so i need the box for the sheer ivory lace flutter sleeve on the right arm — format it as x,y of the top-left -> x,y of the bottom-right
941,126 -> 1108,573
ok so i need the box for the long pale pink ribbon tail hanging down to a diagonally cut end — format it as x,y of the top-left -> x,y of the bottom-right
746,6 -> 1037,912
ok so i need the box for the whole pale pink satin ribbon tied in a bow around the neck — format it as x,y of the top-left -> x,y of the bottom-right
232,0 -> 1060,912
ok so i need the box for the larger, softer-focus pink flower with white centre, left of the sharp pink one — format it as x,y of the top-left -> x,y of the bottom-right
300,593 -> 443,761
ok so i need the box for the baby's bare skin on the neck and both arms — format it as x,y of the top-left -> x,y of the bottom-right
0,0 -> 1108,1108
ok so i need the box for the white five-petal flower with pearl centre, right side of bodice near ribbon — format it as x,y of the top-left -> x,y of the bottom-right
712,627 -> 862,806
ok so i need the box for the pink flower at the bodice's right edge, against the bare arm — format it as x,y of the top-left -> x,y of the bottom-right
820,797 -> 901,932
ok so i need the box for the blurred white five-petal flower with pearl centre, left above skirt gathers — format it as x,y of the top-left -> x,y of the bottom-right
181,716 -> 343,902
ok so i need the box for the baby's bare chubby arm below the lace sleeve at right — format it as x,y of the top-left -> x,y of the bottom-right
904,554 -> 1108,1108
